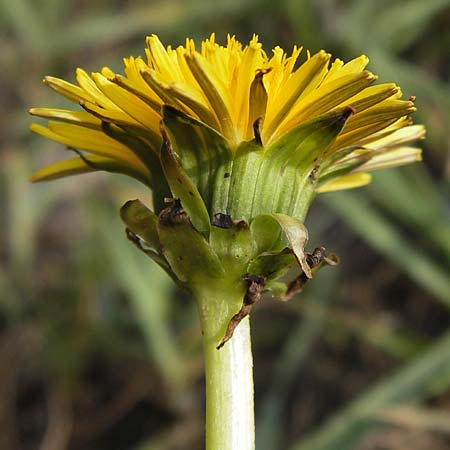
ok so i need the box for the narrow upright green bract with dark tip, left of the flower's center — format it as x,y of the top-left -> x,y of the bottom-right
160,123 -> 210,237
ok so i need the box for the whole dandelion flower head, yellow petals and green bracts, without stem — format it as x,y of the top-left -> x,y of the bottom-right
30,35 -> 424,358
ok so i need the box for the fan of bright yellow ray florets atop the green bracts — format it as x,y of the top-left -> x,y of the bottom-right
30,34 -> 424,191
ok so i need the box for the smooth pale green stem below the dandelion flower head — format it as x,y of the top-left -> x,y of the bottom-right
197,286 -> 255,450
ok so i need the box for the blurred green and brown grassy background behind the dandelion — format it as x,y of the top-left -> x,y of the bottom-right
0,0 -> 450,450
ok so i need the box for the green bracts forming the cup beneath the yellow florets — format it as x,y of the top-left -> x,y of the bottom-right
121,107 -> 353,344
